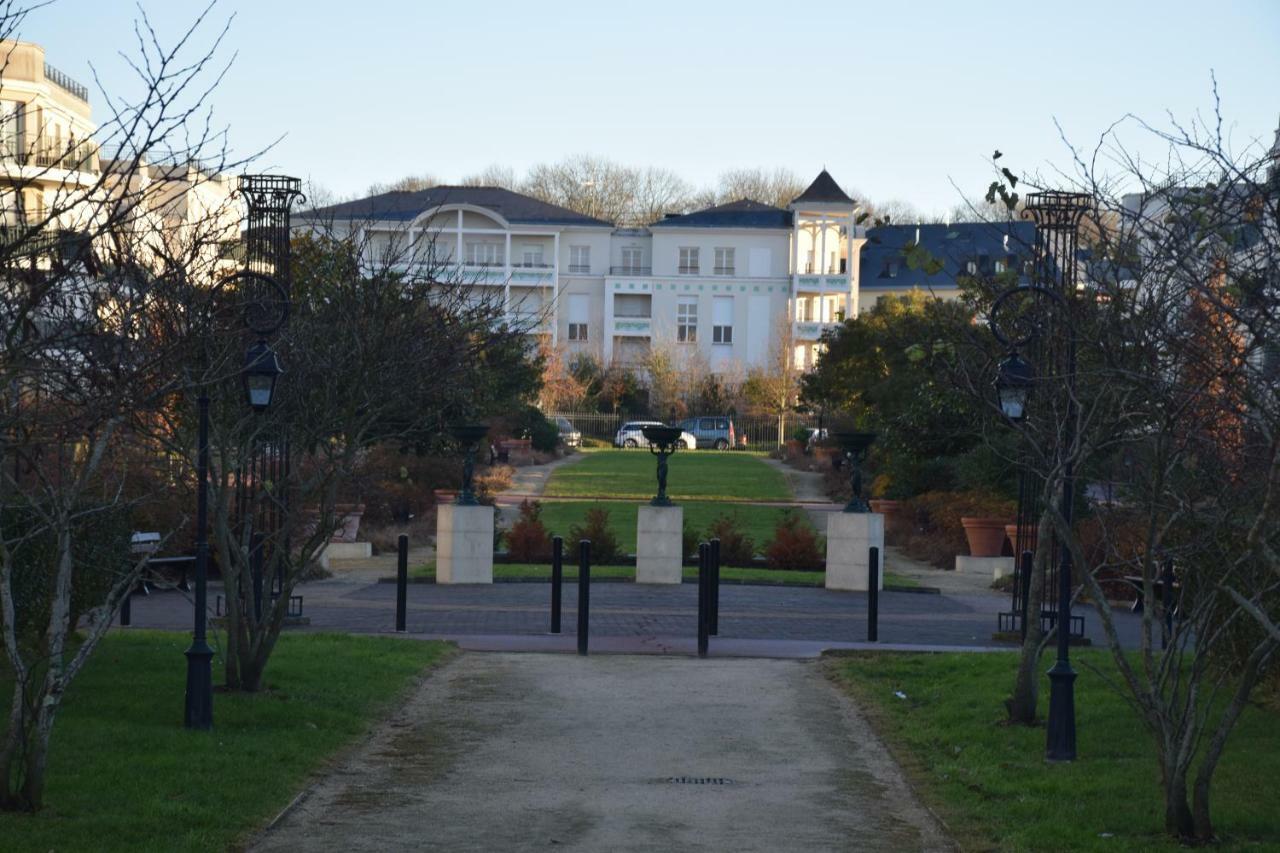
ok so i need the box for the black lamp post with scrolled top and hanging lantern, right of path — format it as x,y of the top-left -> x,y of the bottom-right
989,281 -> 1076,761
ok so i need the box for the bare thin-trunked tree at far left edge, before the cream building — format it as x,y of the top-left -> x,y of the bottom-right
0,3 -> 252,811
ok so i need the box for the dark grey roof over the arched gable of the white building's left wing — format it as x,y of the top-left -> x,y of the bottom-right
298,186 -> 613,228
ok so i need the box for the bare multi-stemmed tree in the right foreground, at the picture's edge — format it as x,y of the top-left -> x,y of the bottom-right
947,96 -> 1280,843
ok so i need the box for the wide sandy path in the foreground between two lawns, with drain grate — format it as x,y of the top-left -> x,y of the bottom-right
251,653 -> 952,853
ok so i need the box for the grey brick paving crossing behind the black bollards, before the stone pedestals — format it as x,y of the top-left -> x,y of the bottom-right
120,580 -> 1138,648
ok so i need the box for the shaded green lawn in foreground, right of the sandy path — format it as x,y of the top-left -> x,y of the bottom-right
828,651 -> 1280,850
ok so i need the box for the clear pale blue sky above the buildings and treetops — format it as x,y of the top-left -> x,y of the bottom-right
22,0 -> 1280,210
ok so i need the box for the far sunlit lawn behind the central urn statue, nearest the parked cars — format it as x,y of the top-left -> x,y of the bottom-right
545,450 -> 791,502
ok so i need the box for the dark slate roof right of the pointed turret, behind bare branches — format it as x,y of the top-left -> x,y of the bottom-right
859,222 -> 1036,289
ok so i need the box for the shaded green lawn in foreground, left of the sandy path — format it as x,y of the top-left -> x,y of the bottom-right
0,631 -> 449,853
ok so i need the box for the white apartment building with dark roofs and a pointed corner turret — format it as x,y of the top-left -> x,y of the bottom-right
294,170 -> 864,373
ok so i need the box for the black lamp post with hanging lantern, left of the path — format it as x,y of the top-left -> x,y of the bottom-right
183,272 -> 289,730
